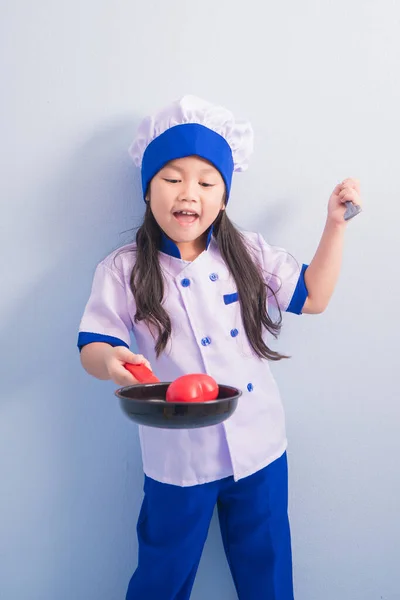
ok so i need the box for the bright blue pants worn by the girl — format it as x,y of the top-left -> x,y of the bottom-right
126,453 -> 293,600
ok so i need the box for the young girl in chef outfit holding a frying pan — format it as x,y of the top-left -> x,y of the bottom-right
78,96 -> 360,600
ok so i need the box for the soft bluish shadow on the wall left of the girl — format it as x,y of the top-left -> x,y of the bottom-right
0,119 -> 148,600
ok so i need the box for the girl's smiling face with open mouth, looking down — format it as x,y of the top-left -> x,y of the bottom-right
148,156 -> 225,258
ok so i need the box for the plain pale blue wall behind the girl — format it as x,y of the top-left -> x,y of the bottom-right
0,0 -> 400,600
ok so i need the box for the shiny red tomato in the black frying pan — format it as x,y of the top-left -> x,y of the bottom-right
166,373 -> 218,402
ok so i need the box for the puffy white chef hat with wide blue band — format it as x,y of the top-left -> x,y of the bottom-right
129,96 -> 253,198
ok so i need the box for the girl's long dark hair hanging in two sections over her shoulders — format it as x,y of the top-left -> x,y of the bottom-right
130,203 -> 288,361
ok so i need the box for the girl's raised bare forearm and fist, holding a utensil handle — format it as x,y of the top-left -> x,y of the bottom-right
303,179 -> 361,314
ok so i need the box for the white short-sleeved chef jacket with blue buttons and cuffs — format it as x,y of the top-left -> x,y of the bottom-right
78,232 -> 307,486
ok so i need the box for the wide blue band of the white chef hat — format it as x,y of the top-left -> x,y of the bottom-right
142,123 -> 234,199
